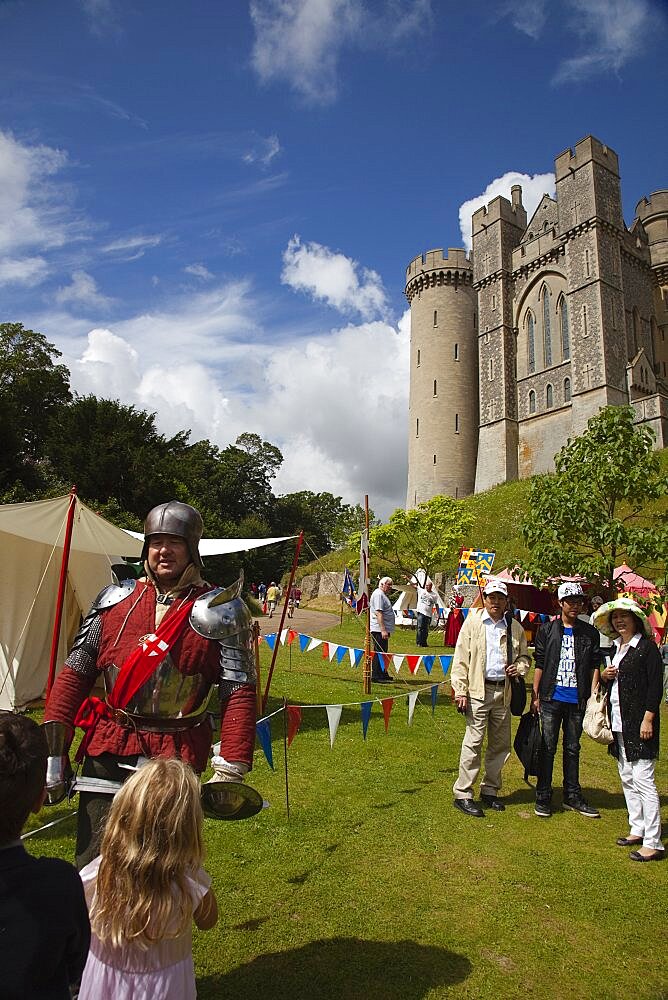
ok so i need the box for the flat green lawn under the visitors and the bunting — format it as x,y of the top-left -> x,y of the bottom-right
26,621 -> 668,1000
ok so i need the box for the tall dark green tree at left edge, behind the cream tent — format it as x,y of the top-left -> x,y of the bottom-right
0,323 -> 71,489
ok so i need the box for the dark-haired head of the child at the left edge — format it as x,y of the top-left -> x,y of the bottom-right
0,712 -> 49,846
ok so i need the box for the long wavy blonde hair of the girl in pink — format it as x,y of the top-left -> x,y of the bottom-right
91,757 -> 204,948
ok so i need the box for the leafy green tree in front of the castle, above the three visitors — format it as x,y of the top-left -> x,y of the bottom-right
519,406 -> 668,593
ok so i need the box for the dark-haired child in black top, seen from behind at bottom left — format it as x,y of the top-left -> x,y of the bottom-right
0,712 -> 90,1000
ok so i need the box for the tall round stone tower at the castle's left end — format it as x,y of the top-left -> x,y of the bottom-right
405,243 -> 478,510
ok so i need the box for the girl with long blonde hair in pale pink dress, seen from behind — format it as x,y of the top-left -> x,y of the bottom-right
79,758 -> 218,1000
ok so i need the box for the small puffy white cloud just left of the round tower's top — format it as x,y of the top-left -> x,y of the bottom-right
281,235 -> 387,319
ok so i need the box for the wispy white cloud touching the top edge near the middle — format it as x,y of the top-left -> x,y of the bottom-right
250,0 -> 431,105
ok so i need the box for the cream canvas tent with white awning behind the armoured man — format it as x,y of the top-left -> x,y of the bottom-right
0,496 -> 289,710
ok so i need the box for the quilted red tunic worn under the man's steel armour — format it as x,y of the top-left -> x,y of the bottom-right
44,583 -> 256,772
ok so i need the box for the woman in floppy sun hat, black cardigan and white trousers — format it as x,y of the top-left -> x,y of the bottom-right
593,597 -> 666,861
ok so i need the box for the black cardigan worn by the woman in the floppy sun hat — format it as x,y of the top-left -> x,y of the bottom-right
605,636 -> 663,760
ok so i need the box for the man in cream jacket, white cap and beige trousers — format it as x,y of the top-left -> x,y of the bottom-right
451,580 -> 530,817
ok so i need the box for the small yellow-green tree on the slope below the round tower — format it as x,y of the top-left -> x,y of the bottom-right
369,496 -> 473,576
